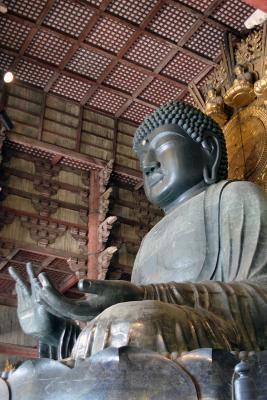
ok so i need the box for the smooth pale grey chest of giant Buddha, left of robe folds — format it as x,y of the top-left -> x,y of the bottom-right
132,195 -> 206,284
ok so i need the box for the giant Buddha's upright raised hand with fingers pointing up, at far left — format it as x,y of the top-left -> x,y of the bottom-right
9,263 -> 65,346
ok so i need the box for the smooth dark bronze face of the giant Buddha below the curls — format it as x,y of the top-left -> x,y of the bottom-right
139,125 -> 209,208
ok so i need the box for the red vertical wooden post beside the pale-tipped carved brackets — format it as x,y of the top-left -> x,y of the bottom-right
87,171 -> 100,279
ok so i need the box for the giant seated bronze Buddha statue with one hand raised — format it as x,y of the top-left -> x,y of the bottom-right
0,102 -> 267,400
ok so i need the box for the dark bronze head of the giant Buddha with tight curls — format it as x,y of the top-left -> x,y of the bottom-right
134,102 -> 227,209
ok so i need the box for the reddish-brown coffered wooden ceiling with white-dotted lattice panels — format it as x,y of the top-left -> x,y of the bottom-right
0,0 -> 254,123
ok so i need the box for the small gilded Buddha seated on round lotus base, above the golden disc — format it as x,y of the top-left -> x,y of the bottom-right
224,65 -> 255,107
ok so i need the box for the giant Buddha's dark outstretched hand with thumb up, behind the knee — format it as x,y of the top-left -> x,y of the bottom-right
39,273 -> 144,321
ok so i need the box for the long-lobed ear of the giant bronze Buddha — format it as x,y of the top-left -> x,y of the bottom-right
201,134 -> 222,185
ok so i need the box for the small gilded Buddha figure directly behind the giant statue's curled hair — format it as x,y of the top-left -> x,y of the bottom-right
205,87 -> 228,127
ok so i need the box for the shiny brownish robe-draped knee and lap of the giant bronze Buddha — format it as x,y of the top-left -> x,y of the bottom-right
72,300 -> 239,359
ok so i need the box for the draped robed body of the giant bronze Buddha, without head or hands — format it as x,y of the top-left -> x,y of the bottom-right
67,181 -> 267,358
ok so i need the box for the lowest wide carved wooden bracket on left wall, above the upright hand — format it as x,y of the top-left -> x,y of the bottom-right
20,216 -> 67,247
